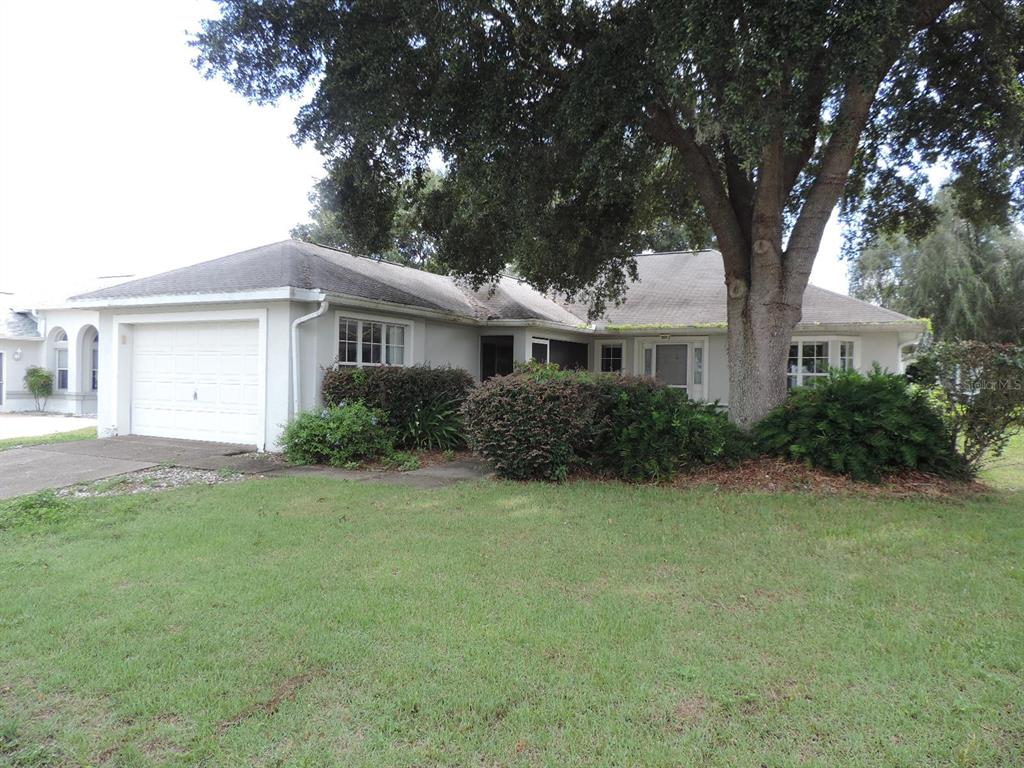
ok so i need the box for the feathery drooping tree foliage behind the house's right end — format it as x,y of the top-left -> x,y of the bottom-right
851,191 -> 1024,342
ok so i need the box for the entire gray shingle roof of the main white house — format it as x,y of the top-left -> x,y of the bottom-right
72,240 -> 909,327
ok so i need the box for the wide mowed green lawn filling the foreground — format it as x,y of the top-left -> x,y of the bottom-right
0,478 -> 1024,767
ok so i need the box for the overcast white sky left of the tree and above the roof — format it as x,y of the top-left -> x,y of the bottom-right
0,0 -> 847,307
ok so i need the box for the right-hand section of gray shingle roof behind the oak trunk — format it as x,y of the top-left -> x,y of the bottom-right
569,251 -> 911,326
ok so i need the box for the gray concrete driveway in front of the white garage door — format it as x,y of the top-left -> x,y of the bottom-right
0,436 -> 256,499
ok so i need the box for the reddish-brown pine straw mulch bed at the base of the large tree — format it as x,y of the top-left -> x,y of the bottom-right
672,457 -> 992,500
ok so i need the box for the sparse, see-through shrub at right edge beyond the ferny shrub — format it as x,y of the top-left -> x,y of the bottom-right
907,341 -> 1024,473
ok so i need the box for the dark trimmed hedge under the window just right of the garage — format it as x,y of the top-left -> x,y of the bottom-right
321,366 -> 473,449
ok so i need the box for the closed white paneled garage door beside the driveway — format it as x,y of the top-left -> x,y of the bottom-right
131,323 -> 262,445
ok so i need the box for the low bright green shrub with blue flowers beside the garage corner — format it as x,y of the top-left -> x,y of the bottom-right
282,401 -> 394,467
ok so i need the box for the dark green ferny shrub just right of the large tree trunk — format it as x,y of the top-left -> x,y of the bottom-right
754,369 -> 965,480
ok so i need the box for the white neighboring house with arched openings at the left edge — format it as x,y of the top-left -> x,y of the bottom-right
0,308 -> 99,416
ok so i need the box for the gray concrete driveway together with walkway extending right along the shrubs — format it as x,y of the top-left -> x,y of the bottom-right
0,435 -> 490,499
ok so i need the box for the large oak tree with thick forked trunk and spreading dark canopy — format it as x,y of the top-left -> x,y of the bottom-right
195,0 -> 1024,426
